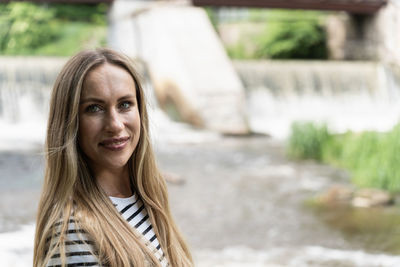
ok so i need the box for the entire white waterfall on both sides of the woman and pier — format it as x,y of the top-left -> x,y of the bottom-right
0,57 -> 400,149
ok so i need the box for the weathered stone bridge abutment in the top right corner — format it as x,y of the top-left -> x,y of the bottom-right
326,0 -> 400,66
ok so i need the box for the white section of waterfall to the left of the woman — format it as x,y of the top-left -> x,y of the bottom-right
0,57 -> 66,149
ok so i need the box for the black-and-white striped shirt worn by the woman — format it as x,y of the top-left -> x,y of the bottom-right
46,194 -> 169,267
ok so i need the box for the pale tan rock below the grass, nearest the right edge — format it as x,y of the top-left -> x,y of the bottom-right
351,188 -> 393,208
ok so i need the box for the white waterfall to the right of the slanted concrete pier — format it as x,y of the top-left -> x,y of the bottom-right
235,61 -> 400,138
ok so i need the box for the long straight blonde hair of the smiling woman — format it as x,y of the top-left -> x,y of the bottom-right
34,48 -> 193,267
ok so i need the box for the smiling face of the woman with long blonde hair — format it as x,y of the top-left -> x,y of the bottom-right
78,63 -> 140,172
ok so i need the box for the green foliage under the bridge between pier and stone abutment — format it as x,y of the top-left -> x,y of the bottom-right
212,9 -> 327,59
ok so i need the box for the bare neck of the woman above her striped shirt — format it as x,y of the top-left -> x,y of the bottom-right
95,166 -> 132,198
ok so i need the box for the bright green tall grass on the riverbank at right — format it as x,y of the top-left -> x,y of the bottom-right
287,122 -> 400,193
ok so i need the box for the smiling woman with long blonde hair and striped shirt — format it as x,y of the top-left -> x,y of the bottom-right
34,49 -> 192,267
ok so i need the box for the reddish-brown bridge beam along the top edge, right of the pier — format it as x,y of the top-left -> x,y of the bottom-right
192,0 -> 387,14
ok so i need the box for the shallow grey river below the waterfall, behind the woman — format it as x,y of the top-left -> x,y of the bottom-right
0,133 -> 400,267
